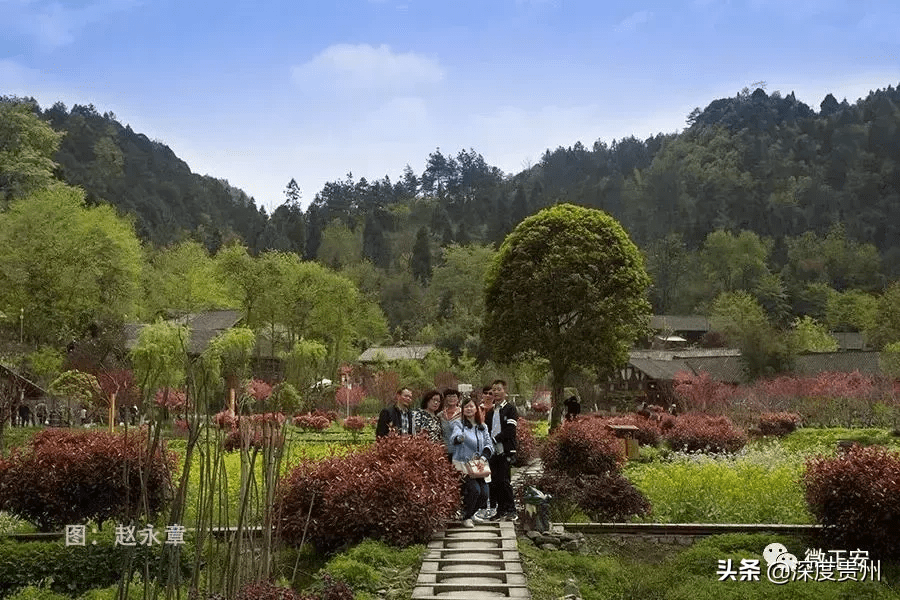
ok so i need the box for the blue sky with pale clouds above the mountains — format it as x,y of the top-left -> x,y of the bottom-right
0,0 -> 900,211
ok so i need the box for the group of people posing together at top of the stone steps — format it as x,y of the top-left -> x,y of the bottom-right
375,379 -> 519,527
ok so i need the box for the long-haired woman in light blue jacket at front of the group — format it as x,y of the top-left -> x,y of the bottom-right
450,397 -> 494,527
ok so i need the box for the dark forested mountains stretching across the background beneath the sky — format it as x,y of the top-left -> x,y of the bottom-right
1,86 -> 900,351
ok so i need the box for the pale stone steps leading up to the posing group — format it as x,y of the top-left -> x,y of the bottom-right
412,522 -> 531,600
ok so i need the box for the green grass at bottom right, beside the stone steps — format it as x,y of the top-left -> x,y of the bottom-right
519,534 -> 900,600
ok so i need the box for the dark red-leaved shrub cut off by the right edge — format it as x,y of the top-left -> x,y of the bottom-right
803,446 -> 900,559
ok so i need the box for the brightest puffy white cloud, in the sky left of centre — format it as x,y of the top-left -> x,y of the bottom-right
291,44 -> 444,95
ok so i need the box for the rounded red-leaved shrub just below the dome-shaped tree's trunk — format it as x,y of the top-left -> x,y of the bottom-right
541,419 -> 625,477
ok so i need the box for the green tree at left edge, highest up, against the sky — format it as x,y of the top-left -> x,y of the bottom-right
0,98 -> 62,201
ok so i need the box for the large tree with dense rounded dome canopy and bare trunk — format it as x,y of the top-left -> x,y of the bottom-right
484,204 -> 650,427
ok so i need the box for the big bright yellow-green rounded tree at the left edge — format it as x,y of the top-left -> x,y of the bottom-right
0,185 -> 143,343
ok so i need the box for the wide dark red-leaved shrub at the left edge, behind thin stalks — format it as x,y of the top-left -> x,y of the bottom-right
0,429 -> 175,531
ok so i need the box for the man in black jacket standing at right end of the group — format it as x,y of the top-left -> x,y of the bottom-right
485,379 -> 519,521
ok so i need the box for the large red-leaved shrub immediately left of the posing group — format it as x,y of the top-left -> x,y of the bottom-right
278,435 -> 459,551
